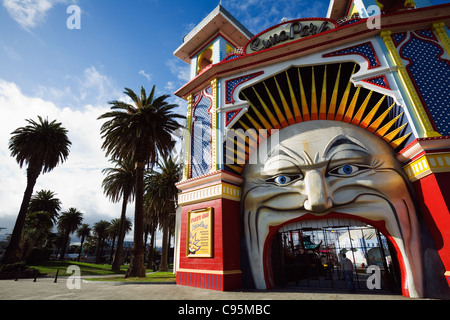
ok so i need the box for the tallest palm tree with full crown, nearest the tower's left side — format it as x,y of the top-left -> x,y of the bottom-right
99,86 -> 184,277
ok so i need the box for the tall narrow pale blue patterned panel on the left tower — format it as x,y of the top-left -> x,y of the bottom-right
191,96 -> 211,178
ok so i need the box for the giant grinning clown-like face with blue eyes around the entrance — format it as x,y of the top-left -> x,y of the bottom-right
242,120 -> 423,297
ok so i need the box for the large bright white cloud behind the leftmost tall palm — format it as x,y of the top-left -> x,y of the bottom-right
0,79 -> 123,232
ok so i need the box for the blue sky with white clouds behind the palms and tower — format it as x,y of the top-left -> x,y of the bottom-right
0,0 -> 448,241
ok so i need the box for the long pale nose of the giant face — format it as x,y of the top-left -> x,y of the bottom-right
303,170 -> 333,213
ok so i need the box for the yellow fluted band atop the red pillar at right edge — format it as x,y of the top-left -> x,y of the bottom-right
403,152 -> 450,181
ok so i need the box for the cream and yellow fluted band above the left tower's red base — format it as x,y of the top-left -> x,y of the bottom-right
178,183 -> 241,205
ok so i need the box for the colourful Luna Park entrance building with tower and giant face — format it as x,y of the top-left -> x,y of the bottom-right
174,0 -> 450,297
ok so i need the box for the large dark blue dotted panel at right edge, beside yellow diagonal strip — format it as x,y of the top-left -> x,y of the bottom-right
400,34 -> 450,135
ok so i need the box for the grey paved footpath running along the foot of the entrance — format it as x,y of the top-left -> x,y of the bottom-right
0,277 -> 412,300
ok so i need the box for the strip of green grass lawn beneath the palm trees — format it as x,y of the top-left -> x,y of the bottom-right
30,260 -> 175,282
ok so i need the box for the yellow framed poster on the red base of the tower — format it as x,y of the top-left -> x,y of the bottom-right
186,208 -> 213,258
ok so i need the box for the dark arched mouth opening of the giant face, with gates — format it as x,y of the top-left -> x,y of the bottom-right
272,219 -> 401,293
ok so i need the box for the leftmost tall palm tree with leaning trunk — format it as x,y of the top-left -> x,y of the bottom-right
3,117 -> 71,263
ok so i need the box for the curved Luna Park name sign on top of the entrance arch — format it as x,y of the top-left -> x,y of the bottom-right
245,19 -> 336,54
